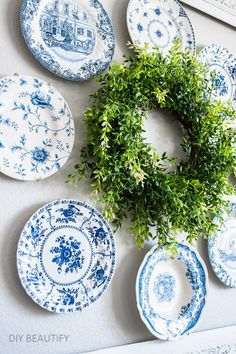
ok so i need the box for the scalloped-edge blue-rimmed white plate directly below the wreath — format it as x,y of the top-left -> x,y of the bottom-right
136,244 -> 208,340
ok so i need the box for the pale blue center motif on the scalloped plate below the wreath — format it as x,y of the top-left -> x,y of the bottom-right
154,272 -> 176,302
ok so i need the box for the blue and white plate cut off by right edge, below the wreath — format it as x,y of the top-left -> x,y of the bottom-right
208,196 -> 236,288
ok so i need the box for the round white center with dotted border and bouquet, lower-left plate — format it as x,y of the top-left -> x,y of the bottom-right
41,226 -> 92,285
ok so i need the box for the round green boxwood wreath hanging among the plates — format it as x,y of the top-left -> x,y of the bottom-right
68,42 -> 236,248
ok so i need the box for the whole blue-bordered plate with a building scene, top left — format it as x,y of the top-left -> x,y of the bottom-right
21,0 -> 115,80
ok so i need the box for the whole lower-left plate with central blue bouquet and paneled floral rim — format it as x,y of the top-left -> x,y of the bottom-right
17,200 -> 115,313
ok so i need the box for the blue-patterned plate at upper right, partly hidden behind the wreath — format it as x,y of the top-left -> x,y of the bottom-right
199,44 -> 236,109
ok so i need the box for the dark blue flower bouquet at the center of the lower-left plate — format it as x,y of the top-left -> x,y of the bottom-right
50,236 -> 84,274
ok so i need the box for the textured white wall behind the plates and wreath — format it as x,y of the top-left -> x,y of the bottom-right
0,0 -> 236,354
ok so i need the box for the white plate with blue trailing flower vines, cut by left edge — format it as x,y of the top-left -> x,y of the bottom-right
0,75 -> 74,180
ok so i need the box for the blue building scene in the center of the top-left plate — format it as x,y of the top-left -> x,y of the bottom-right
40,0 -> 95,55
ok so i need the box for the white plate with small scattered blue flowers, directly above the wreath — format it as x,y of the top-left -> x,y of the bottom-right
127,0 -> 195,54
